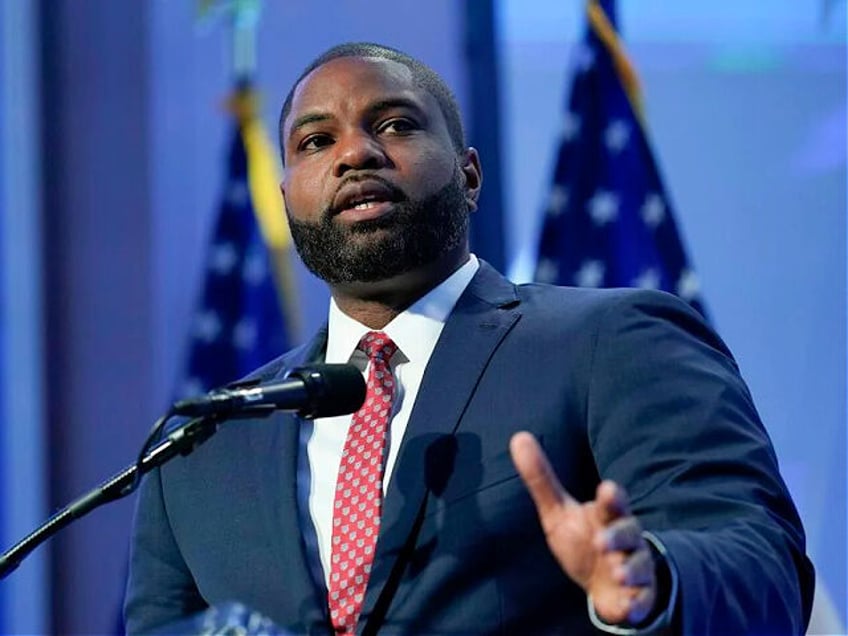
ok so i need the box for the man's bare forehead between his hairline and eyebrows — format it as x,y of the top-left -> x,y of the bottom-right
285,57 -> 438,130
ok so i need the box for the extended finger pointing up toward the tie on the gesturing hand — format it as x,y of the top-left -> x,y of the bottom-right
509,431 -> 577,522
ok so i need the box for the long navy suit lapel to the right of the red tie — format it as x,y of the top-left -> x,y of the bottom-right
360,262 -> 520,631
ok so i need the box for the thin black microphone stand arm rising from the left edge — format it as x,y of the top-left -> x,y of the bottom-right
0,405 -> 275,579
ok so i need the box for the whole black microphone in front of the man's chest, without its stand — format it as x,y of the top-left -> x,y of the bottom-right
171,364 -> 365,419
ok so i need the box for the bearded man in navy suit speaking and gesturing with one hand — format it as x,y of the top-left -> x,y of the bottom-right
126,44 -> 812,634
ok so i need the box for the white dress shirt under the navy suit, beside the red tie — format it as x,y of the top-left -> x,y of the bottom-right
306,254 -> 480,583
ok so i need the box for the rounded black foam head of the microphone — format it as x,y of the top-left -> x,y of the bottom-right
286,364 -> 365,420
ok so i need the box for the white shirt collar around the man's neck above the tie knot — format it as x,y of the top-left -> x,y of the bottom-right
325,254 -> 480,363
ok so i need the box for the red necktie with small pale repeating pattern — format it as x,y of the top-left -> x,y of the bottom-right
328,331 -> 397,634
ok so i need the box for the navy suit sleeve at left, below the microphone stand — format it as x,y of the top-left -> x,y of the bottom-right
124,469 -> 206,634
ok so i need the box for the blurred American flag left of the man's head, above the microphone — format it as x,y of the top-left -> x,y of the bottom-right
178,87 -> 289,397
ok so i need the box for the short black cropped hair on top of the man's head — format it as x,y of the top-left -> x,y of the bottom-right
279,42 -> 465,163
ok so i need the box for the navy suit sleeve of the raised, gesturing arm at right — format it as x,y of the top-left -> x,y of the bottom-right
586,292 -> 813,635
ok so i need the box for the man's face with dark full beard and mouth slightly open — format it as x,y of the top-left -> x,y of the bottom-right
281,57 -> 479,283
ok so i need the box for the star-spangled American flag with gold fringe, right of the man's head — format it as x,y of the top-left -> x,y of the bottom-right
536,0 -> 705,314
